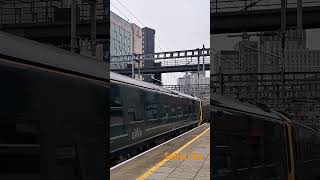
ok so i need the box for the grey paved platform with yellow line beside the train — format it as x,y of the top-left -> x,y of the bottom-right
110,124 -> 210,180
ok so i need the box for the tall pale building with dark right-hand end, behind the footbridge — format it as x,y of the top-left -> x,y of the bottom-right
110,12 -> 161,78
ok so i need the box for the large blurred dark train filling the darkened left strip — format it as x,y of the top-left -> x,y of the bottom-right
0,32 -> 110,180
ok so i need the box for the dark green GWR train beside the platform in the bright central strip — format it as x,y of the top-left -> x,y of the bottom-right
110,72 -> 202,164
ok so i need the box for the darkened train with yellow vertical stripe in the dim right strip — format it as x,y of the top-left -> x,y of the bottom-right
210,94 -> 320,180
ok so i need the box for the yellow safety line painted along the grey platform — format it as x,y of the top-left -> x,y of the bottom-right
137,128 -> 210,180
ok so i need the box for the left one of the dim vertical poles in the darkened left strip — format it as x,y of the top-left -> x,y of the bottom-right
70,0 -> 77,53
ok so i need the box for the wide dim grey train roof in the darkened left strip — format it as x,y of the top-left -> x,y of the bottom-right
0,31 -> 109,79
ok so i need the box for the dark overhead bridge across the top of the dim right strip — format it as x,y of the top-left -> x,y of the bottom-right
210,0 -> 320,34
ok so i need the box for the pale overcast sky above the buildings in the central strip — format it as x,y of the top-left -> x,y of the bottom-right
111,0 -> 210,85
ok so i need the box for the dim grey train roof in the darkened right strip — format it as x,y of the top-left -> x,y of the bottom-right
210,93 -> 283,120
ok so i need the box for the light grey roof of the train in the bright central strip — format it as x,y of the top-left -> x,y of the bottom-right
110,72 -> 200,101
